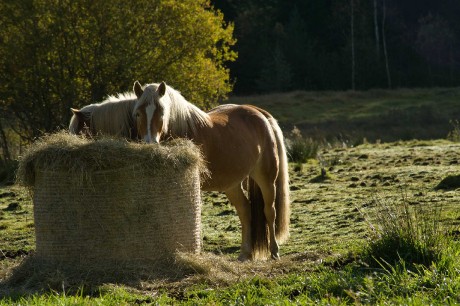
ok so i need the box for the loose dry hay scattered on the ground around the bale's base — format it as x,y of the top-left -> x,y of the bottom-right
0,252 -> 321,297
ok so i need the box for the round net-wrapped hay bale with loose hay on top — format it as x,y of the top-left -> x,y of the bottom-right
17,132 -> 205,265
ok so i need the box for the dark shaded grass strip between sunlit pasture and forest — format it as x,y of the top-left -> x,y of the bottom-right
225,88 -> 460,144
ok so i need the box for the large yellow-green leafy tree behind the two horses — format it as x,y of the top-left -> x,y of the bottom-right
0,0 -> 236,139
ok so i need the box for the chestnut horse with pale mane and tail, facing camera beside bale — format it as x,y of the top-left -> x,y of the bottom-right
133,81 -> 290,260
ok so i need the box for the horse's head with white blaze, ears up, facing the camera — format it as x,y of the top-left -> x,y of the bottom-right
133,81 -> 169,143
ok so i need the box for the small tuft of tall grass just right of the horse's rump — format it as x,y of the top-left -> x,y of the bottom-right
286,126 -> 319,164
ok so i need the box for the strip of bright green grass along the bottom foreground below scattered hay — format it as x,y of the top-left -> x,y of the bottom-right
0,247 -> 460,305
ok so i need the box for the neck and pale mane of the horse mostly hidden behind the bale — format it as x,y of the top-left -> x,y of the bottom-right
80,92 -> 137,137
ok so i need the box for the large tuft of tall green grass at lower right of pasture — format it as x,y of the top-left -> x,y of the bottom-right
363,192 -> 449,270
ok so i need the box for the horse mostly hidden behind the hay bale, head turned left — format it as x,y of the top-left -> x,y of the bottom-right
69,92 -> 137,139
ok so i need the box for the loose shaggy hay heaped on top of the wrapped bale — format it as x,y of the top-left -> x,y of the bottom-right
16,131 -> 207,187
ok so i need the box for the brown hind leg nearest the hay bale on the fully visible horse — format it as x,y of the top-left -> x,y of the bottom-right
225,184 -> 252,261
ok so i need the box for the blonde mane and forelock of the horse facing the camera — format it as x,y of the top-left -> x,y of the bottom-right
133,83 -> 211,137
